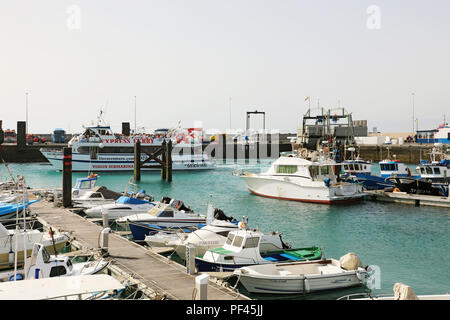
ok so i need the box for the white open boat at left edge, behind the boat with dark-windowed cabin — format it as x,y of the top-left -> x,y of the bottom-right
0,223 -> 69,269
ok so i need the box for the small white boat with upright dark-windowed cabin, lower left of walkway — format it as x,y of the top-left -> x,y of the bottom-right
0,243 -> 109,281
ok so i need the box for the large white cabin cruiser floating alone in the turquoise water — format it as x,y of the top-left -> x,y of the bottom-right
238,154 -> 365,204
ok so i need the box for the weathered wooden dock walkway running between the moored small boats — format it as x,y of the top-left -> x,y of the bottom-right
31,200 -> 248,300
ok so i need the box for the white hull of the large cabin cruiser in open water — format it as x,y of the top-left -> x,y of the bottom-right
241,176 -> 365,204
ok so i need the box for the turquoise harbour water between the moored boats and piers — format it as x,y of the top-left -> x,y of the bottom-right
0,162 -> 450,298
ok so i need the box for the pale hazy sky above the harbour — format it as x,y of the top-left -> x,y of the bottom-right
0,0 -> 450,133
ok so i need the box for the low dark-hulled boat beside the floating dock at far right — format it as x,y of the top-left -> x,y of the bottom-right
386,176 -> 449,197
